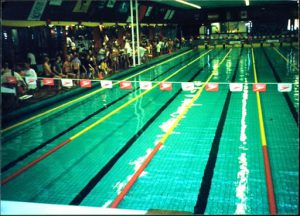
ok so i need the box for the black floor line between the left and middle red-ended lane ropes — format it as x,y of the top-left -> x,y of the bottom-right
70,48 -> 221,205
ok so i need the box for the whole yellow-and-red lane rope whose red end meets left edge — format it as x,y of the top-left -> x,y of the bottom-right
1,50 -> 212,185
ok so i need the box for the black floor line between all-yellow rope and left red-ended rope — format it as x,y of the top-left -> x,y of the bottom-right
1,49 -> 204,173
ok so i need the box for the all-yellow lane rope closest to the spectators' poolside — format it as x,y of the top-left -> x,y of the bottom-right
1,50 -> 192,133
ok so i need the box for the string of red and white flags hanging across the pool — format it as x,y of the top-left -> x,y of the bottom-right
25,77 -> 293,92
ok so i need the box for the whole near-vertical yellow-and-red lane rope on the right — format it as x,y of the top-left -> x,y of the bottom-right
251,48 -> 277,214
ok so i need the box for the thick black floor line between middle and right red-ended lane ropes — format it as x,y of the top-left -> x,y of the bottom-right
194,48 -> 243,214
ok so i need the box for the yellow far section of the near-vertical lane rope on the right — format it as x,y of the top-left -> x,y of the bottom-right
251,48 -> 267,146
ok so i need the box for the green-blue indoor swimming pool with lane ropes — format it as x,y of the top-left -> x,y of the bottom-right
1,47 -> 299,214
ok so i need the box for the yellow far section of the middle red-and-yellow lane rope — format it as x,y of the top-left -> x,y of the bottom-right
160,49 -> 232,143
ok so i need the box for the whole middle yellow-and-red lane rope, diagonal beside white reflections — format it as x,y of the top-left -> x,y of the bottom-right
110,49 -> 232,208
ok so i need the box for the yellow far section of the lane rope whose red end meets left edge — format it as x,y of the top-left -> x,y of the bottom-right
70,50 -> 212,140
